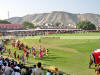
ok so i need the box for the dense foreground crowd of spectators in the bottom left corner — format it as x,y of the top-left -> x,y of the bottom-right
0,56 -> 63,75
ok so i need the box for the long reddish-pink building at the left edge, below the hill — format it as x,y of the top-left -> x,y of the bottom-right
0,24 -> 23,30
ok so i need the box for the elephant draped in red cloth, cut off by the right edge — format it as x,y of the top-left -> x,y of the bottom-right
89,49 -> 100,68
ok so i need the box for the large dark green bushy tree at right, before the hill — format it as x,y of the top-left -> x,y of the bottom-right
76,21 -> 96,30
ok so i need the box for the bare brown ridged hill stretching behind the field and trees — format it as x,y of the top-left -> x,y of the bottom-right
7,11 -> 100,25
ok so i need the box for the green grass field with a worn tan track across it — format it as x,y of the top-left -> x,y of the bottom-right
5,33 -> 100,75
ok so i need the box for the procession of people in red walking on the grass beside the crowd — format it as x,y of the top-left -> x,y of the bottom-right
7,46 -> 48,64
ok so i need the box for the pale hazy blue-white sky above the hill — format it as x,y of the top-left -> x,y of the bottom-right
0,0 -> 100,19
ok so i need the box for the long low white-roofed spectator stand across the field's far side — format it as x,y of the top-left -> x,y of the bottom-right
1,28 -> 81,36
